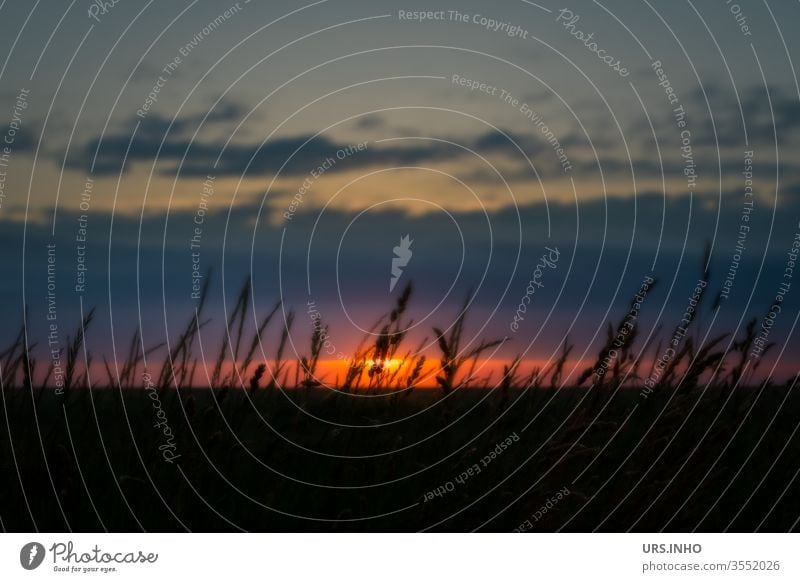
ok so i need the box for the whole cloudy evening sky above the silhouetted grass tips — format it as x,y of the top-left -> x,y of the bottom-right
0,0 -> 800,388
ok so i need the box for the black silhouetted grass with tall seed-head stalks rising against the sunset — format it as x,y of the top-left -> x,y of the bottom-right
0,264 -> 800,531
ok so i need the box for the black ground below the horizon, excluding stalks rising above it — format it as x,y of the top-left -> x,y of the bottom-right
0,386 -> 800,531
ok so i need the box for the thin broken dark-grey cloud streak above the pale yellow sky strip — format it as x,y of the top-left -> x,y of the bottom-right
64,83 -> 800,196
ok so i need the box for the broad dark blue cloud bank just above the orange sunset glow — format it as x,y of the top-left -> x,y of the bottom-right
0,184 -> 800,364
